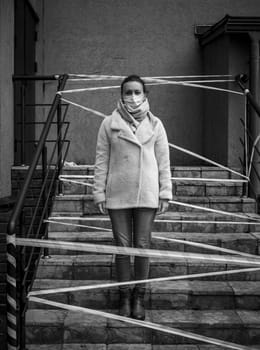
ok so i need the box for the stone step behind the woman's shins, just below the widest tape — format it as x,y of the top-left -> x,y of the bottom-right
36,254 -> 260,281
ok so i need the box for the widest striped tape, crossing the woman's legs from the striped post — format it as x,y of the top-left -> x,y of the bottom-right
16,237 -> 260,265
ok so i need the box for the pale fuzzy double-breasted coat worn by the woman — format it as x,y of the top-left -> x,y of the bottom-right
93,111 -> 172,209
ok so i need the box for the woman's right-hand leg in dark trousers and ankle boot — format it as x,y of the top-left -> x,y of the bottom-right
132,208 -> 156,320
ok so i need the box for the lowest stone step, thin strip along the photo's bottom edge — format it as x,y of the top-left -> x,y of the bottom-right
26,343 -> 258,350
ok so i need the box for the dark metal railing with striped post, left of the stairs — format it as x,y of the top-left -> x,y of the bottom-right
7,75 -> 69,350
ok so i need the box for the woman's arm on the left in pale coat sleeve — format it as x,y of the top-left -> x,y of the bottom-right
93,122 -> 110,208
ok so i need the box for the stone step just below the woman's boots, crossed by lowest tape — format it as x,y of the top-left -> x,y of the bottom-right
26,309 -> 260,345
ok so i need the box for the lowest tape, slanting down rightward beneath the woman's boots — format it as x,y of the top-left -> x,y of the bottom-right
29,296 -> 257,350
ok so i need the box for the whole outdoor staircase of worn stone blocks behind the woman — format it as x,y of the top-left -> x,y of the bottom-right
26,166 -> 260,350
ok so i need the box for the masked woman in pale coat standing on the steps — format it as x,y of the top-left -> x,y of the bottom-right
93,75 -> 172,320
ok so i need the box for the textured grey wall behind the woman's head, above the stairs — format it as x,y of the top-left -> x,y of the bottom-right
35,0 -> 260,164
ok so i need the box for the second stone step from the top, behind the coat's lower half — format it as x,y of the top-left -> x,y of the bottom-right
62,178 -> 243,197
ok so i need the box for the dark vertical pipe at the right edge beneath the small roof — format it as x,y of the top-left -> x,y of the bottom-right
249,32 -> 260,202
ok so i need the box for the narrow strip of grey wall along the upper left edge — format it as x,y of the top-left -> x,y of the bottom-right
0,0 -> 14,198
